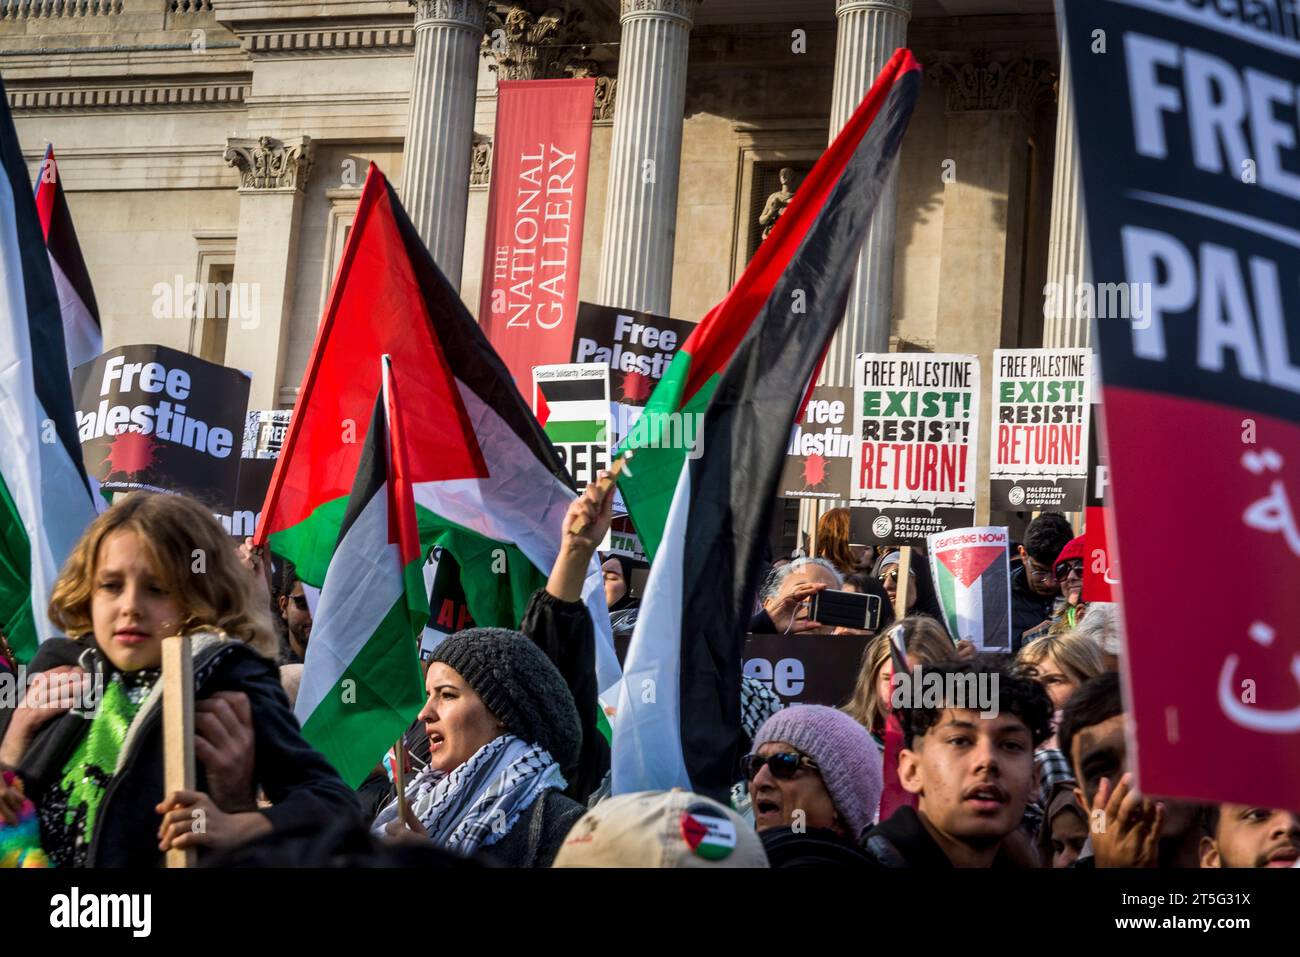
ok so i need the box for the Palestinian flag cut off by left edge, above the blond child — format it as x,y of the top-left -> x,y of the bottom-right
0,83 -> 95,661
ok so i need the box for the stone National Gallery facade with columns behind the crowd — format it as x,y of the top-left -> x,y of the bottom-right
0,0 -> 1086,527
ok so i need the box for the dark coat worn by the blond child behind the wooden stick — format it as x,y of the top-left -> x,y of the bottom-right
0,632 -> 360,867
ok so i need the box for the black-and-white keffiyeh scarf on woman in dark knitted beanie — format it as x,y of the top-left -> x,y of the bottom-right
371,735 -> 566,857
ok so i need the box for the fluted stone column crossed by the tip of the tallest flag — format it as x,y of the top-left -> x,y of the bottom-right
820,0 -> 911,386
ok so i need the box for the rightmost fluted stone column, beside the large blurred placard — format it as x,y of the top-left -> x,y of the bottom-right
1043,43 -> 1092,348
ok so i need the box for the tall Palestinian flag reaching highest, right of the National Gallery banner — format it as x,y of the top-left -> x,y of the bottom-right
614,49 -> 920,801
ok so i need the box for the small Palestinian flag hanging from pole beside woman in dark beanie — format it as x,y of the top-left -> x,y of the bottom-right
294,356 -> 429,788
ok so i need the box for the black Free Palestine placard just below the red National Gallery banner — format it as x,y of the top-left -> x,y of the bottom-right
569,303 -> 696,445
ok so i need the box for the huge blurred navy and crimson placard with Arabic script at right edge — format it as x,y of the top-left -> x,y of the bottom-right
1063,0 -> 1300,807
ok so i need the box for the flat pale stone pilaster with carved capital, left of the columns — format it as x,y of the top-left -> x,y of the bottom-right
222,137 -> 312,408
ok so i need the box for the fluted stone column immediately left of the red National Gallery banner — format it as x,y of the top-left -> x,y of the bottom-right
402,0 -> 486,290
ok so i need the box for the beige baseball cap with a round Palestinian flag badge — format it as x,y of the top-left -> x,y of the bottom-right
554,788 -> 767,867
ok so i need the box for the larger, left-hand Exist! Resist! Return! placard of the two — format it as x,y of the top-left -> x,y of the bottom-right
850,352 -> 979,545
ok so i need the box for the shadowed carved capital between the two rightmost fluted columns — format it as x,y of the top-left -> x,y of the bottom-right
926,49 -> 1057,120
